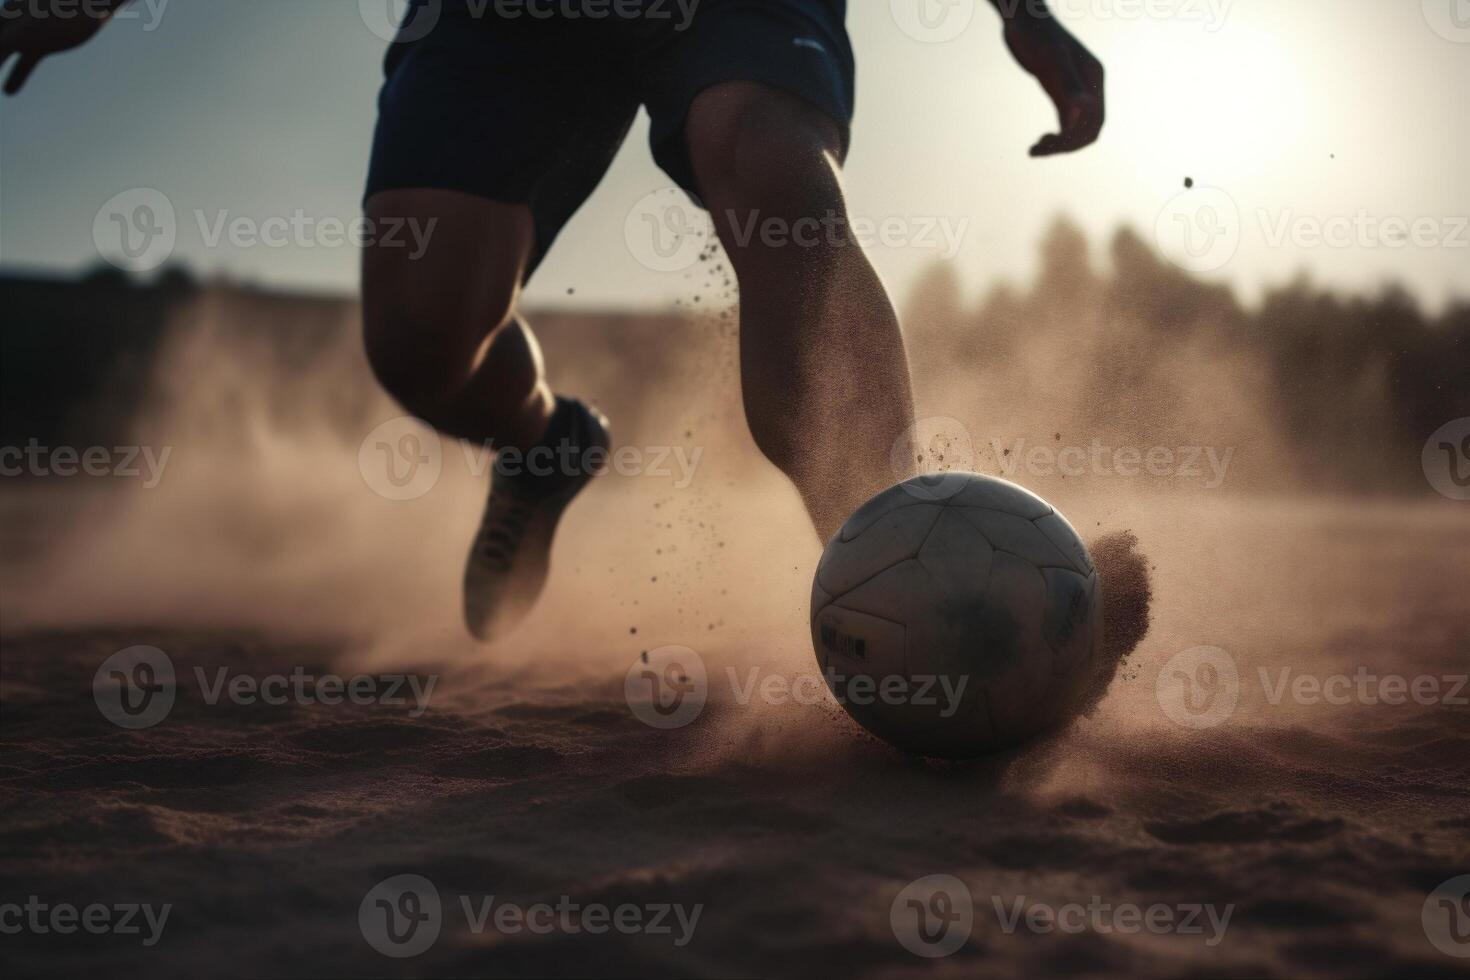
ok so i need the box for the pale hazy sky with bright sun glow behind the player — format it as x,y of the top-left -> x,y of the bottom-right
0,0 -> 1470,310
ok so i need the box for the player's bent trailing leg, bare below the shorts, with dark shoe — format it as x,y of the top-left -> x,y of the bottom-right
363,188 -> 609,639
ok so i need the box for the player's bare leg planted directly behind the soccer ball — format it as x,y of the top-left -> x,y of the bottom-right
685,81 -> 913,541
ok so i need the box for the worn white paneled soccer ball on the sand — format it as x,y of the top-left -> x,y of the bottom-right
811,473 -> 1103,758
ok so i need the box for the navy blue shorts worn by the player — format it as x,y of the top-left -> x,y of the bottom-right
366,0 -> 854,267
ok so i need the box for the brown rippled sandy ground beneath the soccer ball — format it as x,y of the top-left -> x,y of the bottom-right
0,489 -> 1470,977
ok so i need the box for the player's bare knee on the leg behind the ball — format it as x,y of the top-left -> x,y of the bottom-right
686,82 -> 842,220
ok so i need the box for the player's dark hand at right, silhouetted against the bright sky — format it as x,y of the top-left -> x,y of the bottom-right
1005,15 -> 1104,157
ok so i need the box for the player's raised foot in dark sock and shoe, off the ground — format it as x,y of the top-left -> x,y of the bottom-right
465,398 -> 612,642
